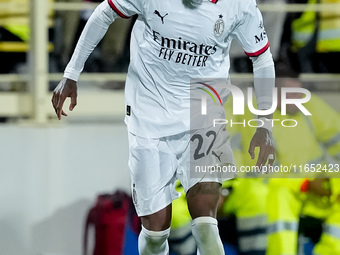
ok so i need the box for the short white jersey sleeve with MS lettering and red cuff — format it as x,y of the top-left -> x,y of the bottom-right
232,0 -> 269,57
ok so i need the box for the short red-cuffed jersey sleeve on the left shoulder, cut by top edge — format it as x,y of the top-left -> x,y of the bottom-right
105,0 -> 143,19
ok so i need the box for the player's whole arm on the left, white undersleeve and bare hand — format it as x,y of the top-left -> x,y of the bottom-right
52,0 -> 134,119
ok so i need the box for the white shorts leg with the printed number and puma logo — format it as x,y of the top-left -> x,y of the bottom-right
177,125 -> 236,192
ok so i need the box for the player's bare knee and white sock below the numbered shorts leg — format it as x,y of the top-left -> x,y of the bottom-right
187,182 -> 224,255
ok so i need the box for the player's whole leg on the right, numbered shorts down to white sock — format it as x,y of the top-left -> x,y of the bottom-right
178,125 -> 234,255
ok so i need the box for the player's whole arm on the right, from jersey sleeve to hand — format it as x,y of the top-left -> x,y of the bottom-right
232,0 -> 275,167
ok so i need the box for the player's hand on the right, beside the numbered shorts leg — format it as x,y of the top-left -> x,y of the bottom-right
248,128 -> 275,170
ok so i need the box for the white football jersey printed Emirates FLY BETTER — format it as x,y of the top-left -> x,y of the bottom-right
107,0 -> 269,138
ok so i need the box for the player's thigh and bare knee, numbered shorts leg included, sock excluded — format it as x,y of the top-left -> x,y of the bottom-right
178,126 -> 235,218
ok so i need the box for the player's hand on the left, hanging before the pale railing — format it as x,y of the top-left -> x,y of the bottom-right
51,78 -> 77,120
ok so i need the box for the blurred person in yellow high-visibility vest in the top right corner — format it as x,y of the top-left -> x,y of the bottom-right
291,0 -> 340,73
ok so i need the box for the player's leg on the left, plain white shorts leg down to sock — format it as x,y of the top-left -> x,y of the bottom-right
129,133 -> 179,255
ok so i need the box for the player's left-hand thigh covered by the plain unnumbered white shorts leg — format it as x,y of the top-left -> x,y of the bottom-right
129,133 -> 179,217
